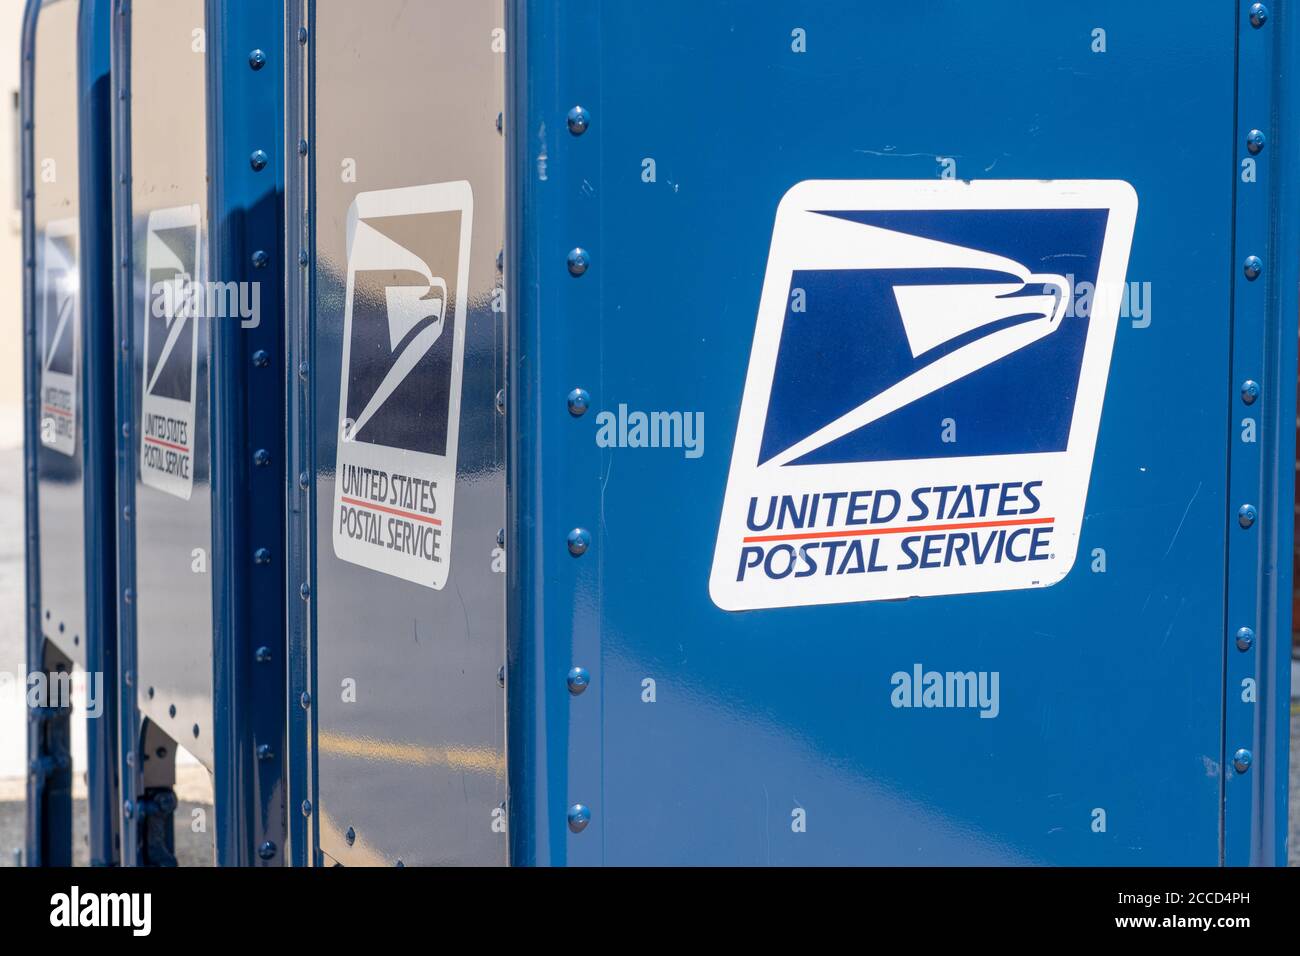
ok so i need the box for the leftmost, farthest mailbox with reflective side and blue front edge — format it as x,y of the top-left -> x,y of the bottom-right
23,0 -> 117,865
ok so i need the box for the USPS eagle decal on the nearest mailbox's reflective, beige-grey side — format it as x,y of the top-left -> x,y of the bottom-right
333,182 -> 473,588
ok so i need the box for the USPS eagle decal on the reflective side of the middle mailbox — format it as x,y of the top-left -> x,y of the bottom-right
140,204 -> 203,501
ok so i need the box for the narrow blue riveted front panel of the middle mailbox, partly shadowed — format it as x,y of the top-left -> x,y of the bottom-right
208,3 -> 287,866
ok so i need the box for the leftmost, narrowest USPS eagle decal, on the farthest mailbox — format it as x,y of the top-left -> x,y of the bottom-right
39,219 -> 81,457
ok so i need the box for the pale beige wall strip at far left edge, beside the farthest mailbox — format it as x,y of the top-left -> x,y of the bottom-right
0,0 -> 23,449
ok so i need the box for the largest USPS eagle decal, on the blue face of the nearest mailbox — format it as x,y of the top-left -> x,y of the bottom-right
710,181 -> 1138,610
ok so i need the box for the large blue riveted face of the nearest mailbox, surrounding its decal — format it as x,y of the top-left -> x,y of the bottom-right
507,3 -> 1296,864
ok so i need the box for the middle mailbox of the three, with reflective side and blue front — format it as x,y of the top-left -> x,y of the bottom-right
113,0 -> 285,865
